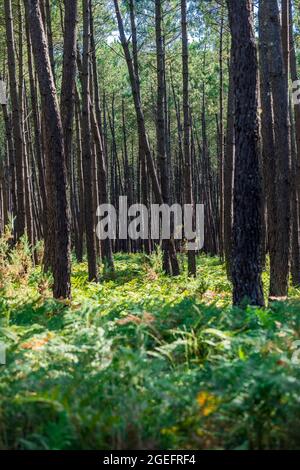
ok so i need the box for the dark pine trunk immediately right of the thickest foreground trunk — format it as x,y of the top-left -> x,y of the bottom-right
261,0 -> 291,297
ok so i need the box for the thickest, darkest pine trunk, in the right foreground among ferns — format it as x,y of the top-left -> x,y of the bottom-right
227,0 -> 264,305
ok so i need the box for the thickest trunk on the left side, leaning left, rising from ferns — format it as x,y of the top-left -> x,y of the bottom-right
25,0 -> 71,298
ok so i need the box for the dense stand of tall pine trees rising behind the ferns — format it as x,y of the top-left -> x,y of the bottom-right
1,1 -> 300,304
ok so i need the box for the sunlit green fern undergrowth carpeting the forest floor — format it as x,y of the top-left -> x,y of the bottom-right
0,241 -> 300,450
